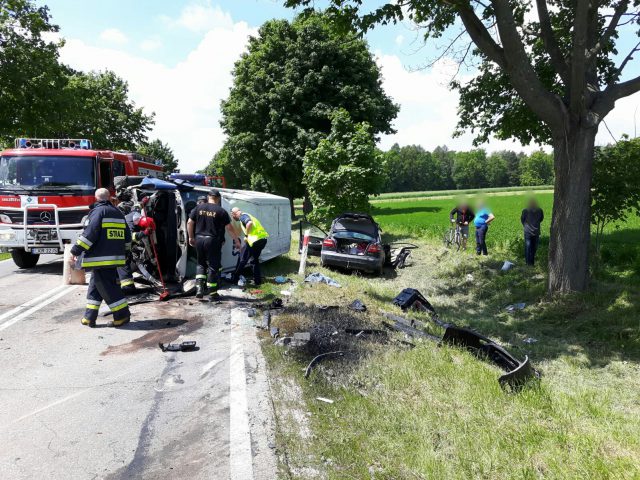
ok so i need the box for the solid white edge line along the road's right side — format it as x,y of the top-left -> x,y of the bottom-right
229,310 -> 253,480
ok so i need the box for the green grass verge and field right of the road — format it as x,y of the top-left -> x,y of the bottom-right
264,189 -> 640,479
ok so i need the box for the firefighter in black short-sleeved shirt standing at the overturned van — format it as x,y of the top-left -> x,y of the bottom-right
187,189 -> 240,300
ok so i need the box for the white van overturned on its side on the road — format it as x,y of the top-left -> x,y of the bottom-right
116,177 -> 291,282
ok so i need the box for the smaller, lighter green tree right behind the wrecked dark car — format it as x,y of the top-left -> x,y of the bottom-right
303,109 -> 384,224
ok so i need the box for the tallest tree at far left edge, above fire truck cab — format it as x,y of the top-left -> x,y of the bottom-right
0,0 -> 67,145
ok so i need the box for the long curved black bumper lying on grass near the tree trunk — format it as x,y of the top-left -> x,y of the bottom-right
442,325 -> 540,390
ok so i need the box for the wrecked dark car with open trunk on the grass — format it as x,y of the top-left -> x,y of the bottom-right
301,213 -> 386,274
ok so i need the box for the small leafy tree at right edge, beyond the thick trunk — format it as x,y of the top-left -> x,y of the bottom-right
591,138 -> 640,249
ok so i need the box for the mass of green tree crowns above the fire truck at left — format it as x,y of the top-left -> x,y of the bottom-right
0,0 -> 153,149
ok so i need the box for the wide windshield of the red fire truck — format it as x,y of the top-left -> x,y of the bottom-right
0,155 -> 96,191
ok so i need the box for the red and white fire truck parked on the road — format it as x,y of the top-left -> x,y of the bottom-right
0,138 -> 163,268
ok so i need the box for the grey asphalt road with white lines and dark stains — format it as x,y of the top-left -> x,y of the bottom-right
0,256 -> 276,480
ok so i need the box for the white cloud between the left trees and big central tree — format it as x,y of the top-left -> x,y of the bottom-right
61,22 -> 255,172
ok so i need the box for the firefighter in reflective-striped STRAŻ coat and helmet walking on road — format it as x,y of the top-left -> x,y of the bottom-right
71,188 -> 131,327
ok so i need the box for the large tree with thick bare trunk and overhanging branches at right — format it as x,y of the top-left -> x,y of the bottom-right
285,0 -> 640,292
